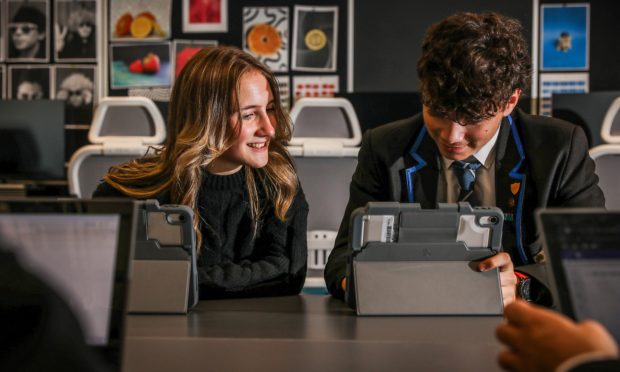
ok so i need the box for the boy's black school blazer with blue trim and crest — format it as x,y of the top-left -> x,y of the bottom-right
325,109 -> 605,298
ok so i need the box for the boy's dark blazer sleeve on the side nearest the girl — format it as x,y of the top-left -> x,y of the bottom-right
324,130 -> 389,299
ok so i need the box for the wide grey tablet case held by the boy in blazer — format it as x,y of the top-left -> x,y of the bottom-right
346,202 -> 503,315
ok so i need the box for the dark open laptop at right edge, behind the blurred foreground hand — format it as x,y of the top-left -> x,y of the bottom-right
536,208 -> 620,341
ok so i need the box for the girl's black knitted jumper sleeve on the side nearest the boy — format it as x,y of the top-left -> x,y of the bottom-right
198,187 -> 308,299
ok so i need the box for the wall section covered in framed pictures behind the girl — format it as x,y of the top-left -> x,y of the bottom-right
0,0 -> 350,166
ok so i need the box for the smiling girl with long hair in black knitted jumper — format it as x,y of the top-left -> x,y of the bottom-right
93,47 -> 308,299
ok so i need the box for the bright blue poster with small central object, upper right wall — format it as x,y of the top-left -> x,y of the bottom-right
540,4 -> 590,71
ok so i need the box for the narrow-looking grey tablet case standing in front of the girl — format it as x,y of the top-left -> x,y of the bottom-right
129,200 -> 198,313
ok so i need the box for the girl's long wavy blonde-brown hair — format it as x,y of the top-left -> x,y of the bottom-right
104,46 -> 298,249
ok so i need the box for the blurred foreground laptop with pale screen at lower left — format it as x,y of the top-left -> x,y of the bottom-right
0,199 -> 136,367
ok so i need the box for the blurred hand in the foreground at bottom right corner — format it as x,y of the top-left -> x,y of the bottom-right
496,301 -> 618,371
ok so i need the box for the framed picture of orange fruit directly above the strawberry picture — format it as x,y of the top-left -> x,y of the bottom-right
109,0 -> 171,42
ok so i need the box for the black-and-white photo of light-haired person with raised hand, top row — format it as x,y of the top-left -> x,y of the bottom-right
54,0 -> 98,62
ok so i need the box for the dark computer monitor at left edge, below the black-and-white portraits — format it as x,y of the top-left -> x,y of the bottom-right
0,100 -> 66,183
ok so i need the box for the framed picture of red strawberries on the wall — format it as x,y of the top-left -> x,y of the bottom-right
110,42 -> 172,89
